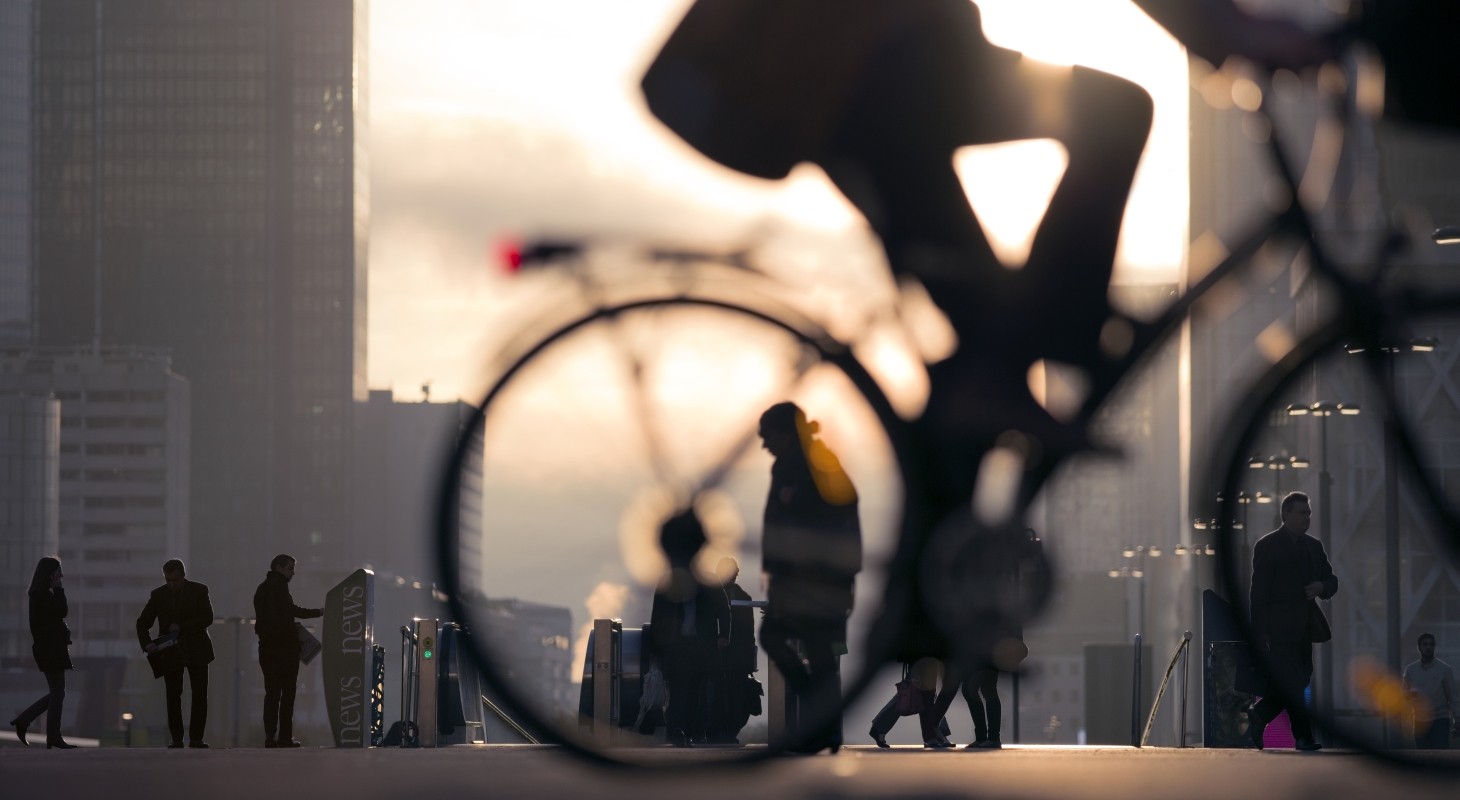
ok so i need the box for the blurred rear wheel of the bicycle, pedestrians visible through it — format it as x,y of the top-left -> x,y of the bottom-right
437,293 -> 908,768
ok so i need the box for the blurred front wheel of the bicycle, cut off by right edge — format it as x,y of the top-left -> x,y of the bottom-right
1207,302 -> 1460,771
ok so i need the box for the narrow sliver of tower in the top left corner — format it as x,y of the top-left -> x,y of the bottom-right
0,0 -> 31,345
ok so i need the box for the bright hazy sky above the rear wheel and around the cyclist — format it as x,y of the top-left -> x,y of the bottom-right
369,0 -> 1187,399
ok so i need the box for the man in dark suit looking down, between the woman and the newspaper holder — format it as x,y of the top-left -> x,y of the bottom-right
137,559 -> 213,747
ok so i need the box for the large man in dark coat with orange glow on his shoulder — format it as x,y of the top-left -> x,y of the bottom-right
761,403 -> 861,752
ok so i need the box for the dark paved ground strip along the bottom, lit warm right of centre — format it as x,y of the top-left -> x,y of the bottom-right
0,745 -> 1460,800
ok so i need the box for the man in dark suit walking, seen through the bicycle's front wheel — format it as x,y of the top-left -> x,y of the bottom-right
1247,492 -> 1339,750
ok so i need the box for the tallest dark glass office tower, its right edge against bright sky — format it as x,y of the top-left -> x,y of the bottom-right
32,0 -> 368,616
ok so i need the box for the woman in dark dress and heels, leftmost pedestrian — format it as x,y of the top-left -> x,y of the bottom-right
10,556 -> 76,750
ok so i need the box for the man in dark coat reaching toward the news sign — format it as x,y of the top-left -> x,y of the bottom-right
254,553 -> 324,747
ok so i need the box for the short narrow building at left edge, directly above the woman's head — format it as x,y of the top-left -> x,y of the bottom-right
0,388 -> 61,666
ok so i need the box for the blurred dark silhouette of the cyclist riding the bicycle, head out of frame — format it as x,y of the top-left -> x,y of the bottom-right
642,0 -> 1332,475
